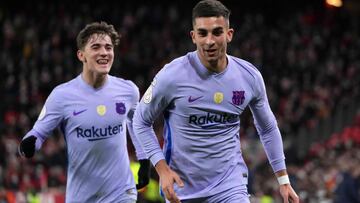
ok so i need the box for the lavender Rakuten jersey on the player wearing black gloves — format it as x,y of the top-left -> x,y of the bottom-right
24,75 -> 145,202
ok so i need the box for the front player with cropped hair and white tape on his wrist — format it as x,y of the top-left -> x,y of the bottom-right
133,0 -> 299,203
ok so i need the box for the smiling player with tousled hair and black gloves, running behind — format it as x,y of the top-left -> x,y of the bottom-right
19,22 -> 150,203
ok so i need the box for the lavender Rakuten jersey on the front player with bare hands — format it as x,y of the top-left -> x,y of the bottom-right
133,51 -> 285,200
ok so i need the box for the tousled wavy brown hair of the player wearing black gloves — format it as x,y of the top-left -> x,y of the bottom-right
76,21 -> 120,50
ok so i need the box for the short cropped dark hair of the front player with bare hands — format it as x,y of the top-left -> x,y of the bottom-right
192,0 -> 230,25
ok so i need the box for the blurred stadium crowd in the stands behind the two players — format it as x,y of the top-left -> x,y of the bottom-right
0,1 -> 360,203
